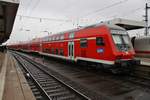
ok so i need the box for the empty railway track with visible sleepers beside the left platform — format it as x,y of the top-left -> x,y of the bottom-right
13,54 -> 90,100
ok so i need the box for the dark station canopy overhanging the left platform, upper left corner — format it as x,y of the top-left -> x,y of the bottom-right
0,0 -> 19,44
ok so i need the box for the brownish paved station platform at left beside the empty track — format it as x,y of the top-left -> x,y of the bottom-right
0,52 -> 36,100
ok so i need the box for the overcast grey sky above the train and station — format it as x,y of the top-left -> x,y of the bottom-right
7,0 -> 150,43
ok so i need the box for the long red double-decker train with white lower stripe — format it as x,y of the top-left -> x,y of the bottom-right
8,24 -> 139,72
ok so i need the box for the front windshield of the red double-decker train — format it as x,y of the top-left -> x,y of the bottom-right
112,30 -> 132,51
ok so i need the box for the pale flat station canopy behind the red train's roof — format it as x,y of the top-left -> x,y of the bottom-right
106,18 -> 145,30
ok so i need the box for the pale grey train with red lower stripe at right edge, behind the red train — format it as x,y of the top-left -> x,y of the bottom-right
132,36 -> 150,58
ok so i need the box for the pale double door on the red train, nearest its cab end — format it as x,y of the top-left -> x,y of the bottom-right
68,41 -> 74,60
